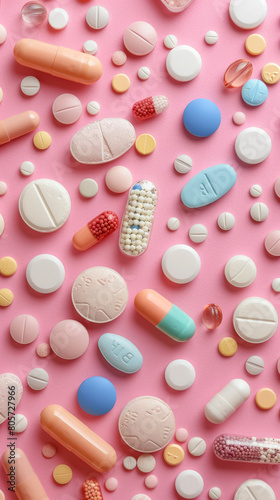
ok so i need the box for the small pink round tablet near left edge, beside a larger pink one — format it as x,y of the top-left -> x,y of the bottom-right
10,314 -> 40,344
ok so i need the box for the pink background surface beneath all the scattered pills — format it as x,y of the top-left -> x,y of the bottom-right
0,0 -> 280,500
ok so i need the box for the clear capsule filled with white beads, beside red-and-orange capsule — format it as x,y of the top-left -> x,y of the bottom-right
119,180 -> 158,257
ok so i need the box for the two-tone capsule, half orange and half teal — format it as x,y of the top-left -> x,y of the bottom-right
134,289 -> 195,342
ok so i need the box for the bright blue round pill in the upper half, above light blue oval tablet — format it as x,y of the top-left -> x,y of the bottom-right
183,99 -> 221,137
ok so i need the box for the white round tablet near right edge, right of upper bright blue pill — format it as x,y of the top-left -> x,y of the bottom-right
235,127 -> 271,165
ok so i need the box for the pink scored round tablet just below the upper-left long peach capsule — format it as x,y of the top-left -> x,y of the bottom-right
52,94 -> 82,125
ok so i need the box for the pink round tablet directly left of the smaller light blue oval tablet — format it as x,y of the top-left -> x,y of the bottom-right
50,319 -> 89,359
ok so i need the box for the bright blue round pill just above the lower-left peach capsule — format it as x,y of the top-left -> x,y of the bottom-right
78,377 -> 117,416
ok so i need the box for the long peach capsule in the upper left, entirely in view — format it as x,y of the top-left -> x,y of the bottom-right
14,38 -> 102,85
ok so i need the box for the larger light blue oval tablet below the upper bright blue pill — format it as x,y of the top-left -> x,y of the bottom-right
181,163 -> 236,208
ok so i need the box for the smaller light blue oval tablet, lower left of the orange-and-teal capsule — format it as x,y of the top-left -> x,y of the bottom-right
98,333 -> 143,373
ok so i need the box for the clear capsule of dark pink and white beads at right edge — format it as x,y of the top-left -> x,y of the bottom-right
213,434 -> 280,464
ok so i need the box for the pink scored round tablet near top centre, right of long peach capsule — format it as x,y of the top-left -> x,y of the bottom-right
123,21 -> 157,56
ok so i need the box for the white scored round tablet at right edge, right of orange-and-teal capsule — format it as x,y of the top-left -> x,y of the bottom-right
233,297 -> 278,344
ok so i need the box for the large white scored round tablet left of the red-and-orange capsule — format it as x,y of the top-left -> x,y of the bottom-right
19,179 -> 71,233
